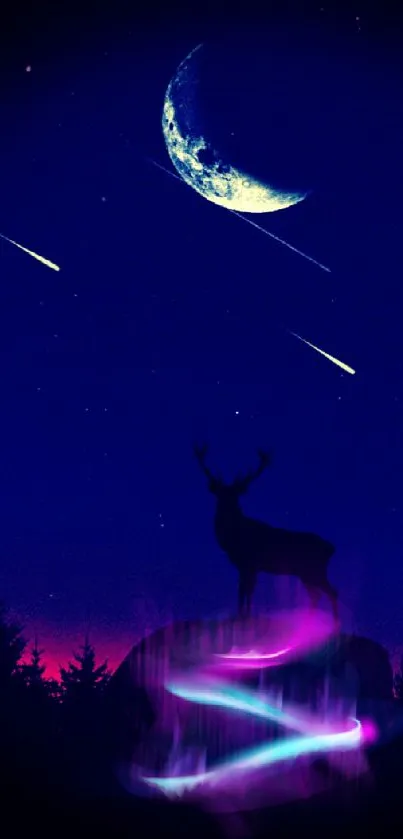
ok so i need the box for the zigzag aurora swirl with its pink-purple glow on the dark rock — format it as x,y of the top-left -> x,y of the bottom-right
124,612 -> 376,810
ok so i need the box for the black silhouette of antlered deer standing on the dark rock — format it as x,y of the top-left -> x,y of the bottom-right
194,445 -> 339,623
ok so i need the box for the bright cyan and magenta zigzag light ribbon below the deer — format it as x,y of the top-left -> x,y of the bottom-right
137,617 -> 377,796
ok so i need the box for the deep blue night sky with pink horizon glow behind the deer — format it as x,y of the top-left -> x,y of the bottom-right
0,4 -> 403,672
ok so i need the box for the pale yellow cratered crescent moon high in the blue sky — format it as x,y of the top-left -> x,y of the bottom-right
162,44 -> 307,213
